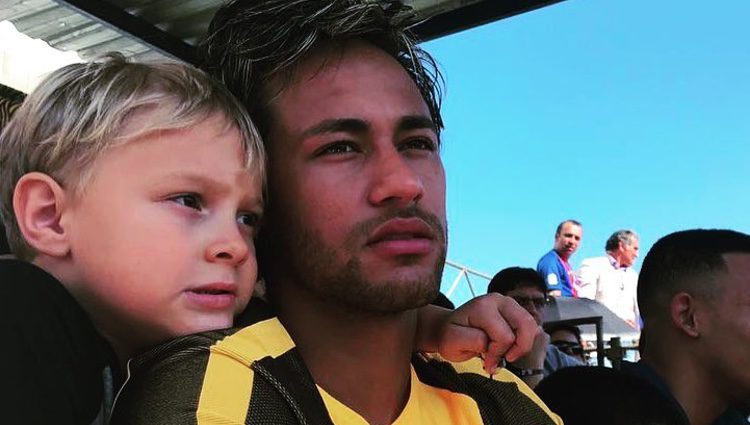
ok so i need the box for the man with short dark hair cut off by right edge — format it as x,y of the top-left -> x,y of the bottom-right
536,230 -> 750,425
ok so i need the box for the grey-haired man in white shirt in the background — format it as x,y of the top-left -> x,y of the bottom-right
578,230 -> 640,329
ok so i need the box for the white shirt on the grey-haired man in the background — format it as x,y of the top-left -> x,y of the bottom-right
578,255 -> 639,326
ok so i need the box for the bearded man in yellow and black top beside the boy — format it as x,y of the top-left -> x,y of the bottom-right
108,0 -> 557,425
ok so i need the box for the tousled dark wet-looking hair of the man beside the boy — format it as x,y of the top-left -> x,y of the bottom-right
201,0 -> 443,142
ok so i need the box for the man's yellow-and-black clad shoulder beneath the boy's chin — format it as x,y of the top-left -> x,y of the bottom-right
112,318 -> 312,425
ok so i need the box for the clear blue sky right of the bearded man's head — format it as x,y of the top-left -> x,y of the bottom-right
424,0 -> 750,302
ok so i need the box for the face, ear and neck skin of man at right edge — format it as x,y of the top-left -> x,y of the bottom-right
643,253 -> 750,425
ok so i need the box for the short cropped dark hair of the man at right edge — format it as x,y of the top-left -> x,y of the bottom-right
638,229 -> 750,324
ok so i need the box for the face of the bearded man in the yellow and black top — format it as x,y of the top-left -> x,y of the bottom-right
264,43 -> 446,313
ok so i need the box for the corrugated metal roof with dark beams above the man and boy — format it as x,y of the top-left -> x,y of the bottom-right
0,0 -> 561,62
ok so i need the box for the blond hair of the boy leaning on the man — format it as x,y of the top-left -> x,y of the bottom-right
0,53 -> 265,261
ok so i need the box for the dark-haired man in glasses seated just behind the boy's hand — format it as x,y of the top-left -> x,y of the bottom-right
487,267 -> 584,388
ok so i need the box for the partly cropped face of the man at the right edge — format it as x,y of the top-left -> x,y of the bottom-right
701,254 -> 750,403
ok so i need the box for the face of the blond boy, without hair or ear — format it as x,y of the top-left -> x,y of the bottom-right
61,115 -> 262,355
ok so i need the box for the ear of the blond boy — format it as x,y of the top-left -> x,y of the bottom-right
13,172 -> 70,257
